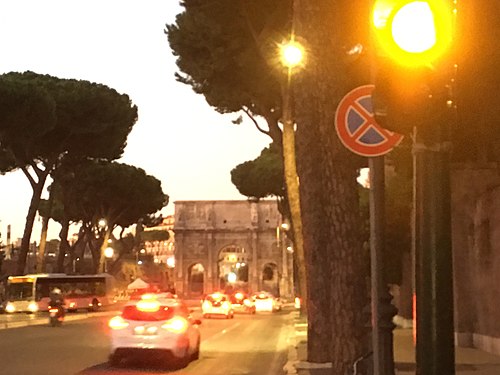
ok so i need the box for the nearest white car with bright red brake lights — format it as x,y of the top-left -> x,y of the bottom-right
108,294 -> 201,366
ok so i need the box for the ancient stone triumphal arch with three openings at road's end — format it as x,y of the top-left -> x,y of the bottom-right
174,200 -> 293,298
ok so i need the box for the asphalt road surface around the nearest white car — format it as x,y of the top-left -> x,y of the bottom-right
0,312 -> 289,375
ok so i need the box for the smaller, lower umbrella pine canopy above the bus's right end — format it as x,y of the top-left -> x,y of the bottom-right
52,159 -> 168,269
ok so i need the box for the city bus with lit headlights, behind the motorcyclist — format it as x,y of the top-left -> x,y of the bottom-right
4,273 -> 114,313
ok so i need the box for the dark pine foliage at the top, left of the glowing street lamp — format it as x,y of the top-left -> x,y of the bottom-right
166,0 -> 291,143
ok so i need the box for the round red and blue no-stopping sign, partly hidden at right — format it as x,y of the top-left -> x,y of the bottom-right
335,85 -> 403,156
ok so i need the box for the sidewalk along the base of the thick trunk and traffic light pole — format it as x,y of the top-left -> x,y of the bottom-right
284,312 -> 500,375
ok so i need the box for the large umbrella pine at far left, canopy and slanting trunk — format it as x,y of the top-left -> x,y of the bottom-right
0,71 -> 137,274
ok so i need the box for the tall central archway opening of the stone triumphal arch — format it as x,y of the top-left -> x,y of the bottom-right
217,245 -> 250,293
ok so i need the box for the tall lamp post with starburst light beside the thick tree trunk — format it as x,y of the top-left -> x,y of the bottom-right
279,39 -> 307,312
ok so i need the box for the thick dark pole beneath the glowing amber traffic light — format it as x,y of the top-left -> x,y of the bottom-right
413,116 -> 455,375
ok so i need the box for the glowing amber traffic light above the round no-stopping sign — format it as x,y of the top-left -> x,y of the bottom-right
371,0 -> 454,138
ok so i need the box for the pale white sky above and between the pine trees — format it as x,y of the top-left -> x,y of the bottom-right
0,0 -> 270,242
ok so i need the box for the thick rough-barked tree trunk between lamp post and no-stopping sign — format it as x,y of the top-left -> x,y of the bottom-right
295,0 -> 368,375
